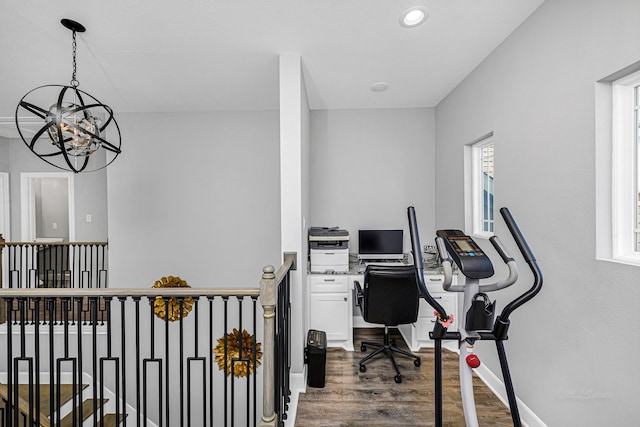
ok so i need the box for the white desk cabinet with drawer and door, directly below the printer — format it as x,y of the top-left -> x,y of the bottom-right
309,274 -> 353,351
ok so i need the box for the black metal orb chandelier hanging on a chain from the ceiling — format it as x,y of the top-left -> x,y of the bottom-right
16,19 -> 122,173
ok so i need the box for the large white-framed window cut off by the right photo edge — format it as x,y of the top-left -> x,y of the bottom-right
611,72 -> 640,263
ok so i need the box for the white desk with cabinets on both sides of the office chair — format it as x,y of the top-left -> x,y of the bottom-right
307,266 -> 459,351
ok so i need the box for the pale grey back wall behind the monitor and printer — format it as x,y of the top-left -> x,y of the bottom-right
310,108 -> 435,253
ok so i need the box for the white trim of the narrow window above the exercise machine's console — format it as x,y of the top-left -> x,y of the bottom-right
465,132 -> 495,239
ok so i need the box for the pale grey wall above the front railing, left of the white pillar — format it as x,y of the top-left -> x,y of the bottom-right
108,111 -> 281,288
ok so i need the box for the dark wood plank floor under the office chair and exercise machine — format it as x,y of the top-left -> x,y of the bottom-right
295,328 -> 513,427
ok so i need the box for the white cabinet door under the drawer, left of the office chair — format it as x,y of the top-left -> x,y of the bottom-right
309,293 -> 349,341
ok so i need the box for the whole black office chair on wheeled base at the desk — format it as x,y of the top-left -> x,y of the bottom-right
355,265 -> 420,383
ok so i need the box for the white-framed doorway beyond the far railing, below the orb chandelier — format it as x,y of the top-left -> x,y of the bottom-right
20,172 -> 76,242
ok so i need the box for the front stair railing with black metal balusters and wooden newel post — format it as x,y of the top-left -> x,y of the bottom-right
0,260 -> 294,427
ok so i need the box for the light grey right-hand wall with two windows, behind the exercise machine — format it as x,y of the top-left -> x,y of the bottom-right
435,0 -> 640,426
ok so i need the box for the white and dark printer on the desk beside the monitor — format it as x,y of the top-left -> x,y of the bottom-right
309,227 -> 349,273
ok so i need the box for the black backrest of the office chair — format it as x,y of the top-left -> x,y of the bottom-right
362,265 -> 420,326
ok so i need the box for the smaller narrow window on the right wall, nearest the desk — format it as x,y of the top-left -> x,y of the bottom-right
467,134 -> 494,237
